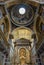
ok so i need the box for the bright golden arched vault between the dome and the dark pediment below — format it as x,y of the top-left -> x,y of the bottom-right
11,27 -> 34,42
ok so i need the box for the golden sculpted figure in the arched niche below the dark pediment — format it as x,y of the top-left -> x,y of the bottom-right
19,48 -> 26,65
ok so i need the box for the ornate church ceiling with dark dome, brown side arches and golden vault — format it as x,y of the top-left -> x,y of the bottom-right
0,0 -> 44,54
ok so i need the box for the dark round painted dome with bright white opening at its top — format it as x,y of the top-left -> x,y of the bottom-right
10,4 -> 34,26
